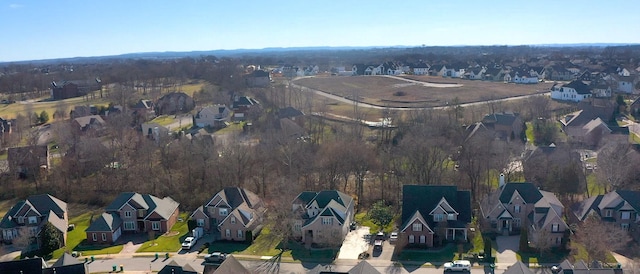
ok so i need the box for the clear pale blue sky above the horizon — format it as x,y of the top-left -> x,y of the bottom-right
0,0 -> 640,62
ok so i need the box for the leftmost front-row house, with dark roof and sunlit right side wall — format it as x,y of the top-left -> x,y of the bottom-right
0,194 -> 69,250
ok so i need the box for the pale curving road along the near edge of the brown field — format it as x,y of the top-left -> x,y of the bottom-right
291,77 -> 551,110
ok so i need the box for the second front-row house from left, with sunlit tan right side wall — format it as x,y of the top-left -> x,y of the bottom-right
85,192 -> 180,244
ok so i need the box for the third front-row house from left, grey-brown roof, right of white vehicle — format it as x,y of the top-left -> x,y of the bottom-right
189,187 -> 266,241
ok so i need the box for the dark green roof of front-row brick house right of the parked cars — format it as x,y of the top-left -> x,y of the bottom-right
401,185 -> 471,227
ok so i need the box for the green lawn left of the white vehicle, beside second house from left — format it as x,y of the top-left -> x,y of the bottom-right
136,213 -> 189,252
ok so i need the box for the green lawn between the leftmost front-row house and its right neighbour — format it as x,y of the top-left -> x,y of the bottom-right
53,210 -> 122,259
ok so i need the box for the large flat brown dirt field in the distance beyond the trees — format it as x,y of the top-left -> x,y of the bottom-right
296,76 -> 552,107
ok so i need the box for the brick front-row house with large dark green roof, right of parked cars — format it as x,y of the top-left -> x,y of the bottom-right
398,185 -> 471,248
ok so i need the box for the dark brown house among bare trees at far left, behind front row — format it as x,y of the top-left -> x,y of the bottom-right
7,145 -> 50,179
